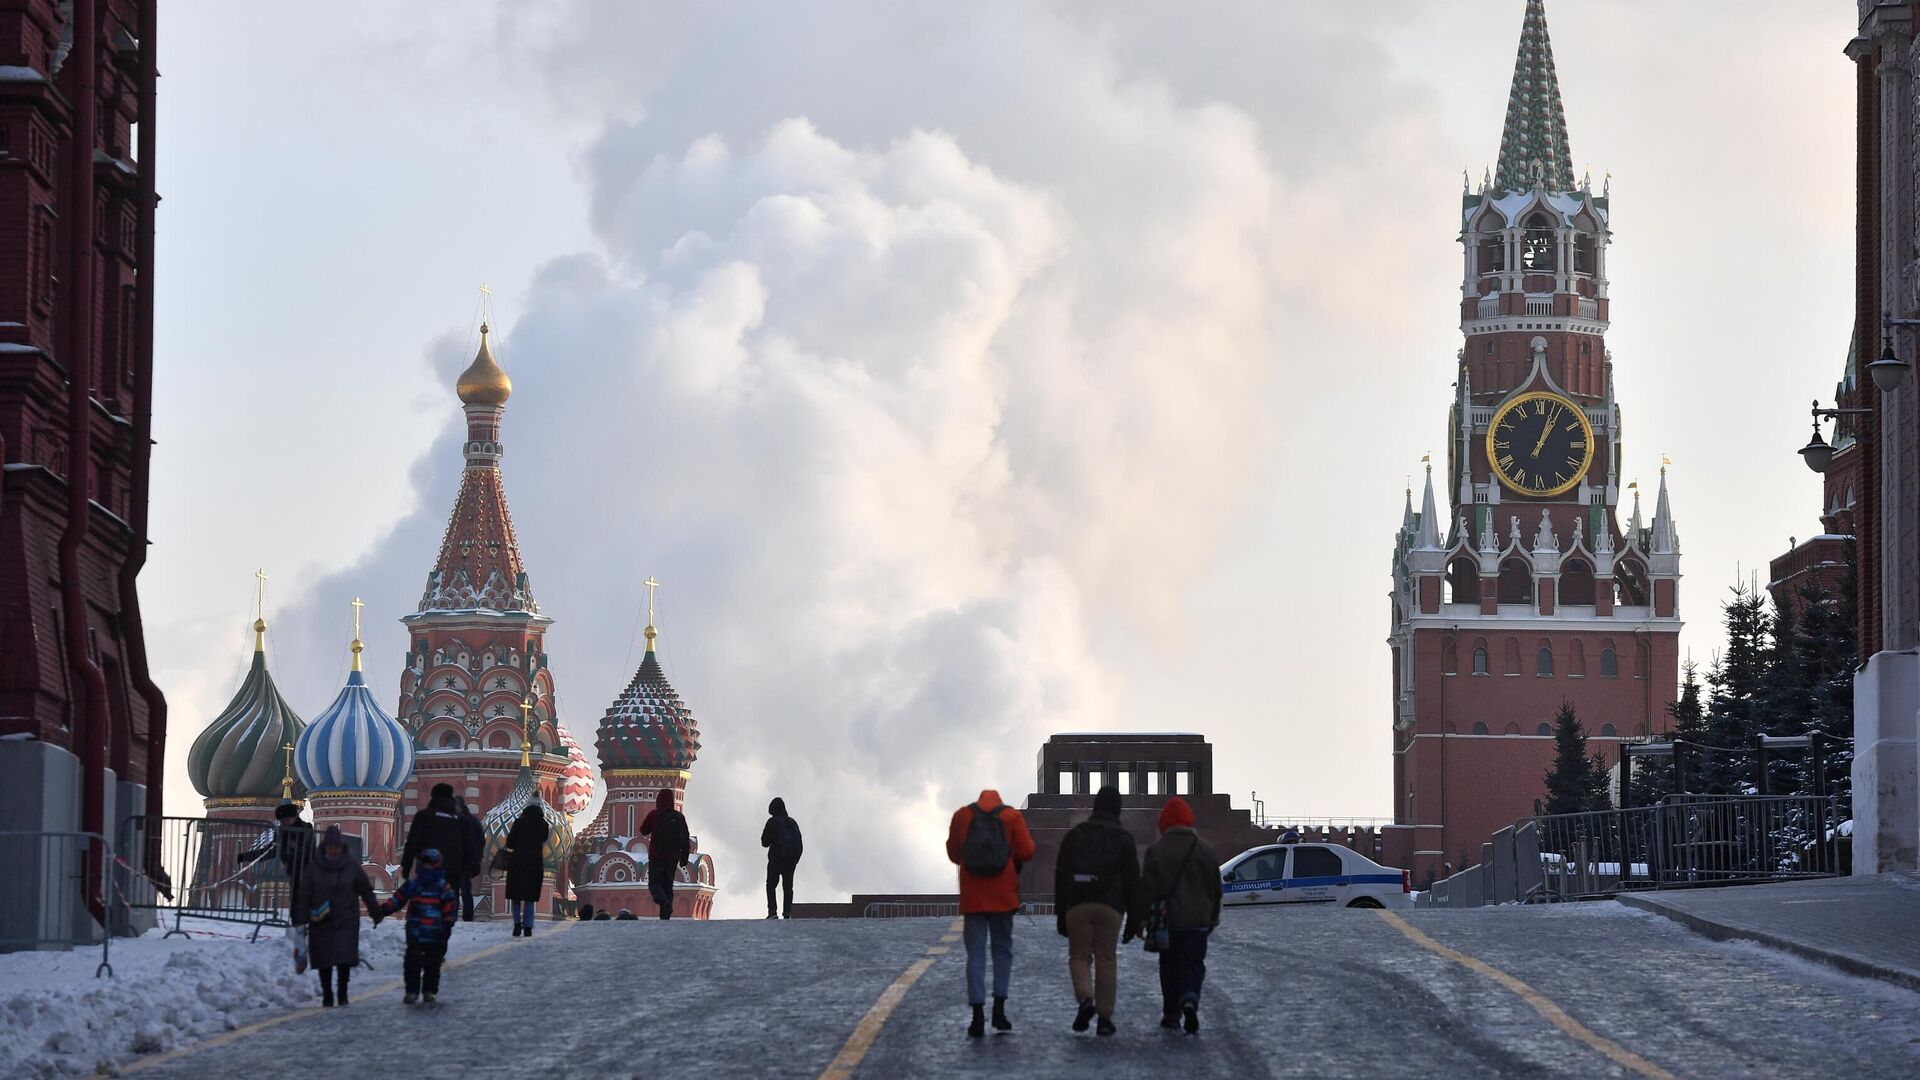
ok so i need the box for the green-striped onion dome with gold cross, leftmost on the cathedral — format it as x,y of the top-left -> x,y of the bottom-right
186,619 -> 307,799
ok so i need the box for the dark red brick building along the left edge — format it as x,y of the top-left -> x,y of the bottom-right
0,0 -> 167,864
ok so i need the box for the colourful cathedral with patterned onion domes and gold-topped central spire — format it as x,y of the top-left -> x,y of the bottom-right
188,323 -> 714,919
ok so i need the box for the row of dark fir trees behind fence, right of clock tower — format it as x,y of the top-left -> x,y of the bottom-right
1542,544 -> 1859,821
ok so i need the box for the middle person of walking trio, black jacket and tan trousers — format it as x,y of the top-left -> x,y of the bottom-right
1054,784 -> 1140,1036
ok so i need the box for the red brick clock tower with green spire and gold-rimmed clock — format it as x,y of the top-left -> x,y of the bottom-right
1388,0 -> 1680,876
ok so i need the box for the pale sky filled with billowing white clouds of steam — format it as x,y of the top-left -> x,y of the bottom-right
142,0 -> 1855,915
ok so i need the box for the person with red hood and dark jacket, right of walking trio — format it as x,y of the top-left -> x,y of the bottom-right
1135,796 -> 1219,1034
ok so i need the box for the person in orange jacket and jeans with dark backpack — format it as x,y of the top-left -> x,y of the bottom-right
947,788 -> 1033,1038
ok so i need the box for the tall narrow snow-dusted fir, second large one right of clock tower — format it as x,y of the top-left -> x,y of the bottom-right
1699,584 -> 1774,796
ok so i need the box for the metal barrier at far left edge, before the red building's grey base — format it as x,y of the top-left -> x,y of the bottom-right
0,830 -> 113,978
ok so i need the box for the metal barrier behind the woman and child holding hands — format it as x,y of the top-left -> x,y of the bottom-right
113,817 -> 295,940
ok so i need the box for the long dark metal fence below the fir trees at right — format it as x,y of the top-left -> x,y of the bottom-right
1519,796 -> 1847,901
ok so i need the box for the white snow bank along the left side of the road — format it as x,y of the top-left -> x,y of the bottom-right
0,919 -> 511,1078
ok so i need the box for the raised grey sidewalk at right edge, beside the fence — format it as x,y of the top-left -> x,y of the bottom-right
1620,871 -> 1920,990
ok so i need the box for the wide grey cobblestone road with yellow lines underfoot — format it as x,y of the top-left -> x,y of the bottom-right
123,903 -> 1920,1080
